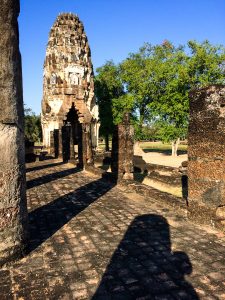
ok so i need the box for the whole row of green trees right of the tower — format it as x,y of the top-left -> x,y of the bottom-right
95,41 -> 225,155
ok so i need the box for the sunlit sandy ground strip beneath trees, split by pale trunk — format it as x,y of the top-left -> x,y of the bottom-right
140,142 -> 187,155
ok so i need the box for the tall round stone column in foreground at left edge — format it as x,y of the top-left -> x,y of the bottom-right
0,0 -> 27,265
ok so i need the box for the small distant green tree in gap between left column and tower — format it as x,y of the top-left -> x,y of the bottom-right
24,108 -> 42,142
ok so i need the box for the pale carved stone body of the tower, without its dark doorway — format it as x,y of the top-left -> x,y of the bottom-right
42,14 -> 98,147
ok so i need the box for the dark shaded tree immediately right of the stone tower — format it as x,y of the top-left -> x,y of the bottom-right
95,61 -> 124,151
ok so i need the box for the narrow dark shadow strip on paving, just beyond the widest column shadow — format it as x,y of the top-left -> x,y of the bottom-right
27,168 -> 81,189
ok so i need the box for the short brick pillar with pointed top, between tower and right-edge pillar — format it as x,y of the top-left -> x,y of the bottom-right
111,113 -> 134,181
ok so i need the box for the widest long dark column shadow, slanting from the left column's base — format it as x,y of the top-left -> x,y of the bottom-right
27,179 -> 114,254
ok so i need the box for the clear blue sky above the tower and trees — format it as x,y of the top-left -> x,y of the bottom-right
19,0 -> 225,113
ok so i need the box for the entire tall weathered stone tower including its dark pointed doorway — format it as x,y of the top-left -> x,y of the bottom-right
42,14 -> 99,165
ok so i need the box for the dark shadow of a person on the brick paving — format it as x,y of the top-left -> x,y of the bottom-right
92,214 -> 199,300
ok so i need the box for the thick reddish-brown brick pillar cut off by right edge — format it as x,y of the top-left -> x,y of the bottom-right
188,86 -> 225,229
